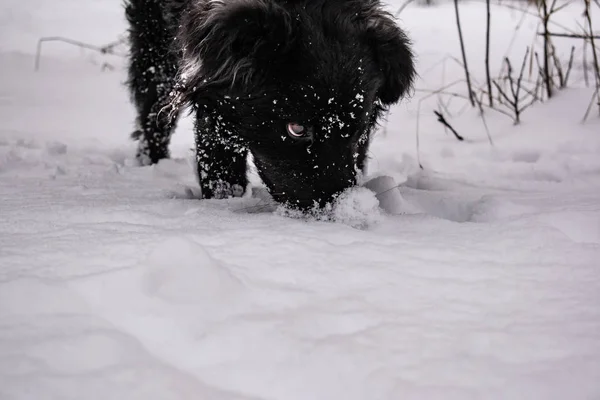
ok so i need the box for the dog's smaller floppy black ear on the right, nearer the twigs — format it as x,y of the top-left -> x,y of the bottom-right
366,11 -> 415,105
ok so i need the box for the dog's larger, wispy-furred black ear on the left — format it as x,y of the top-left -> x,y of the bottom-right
179,0 -> 292,92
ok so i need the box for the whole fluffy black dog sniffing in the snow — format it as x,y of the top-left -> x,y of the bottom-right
126,0 -> 414,209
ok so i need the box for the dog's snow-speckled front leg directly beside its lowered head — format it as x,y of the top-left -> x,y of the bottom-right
196,118 -> 248,199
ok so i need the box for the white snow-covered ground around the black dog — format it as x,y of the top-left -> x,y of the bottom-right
0,0 -> 600,400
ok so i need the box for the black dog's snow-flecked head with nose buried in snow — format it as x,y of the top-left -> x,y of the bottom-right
180,0 -> 414,208
